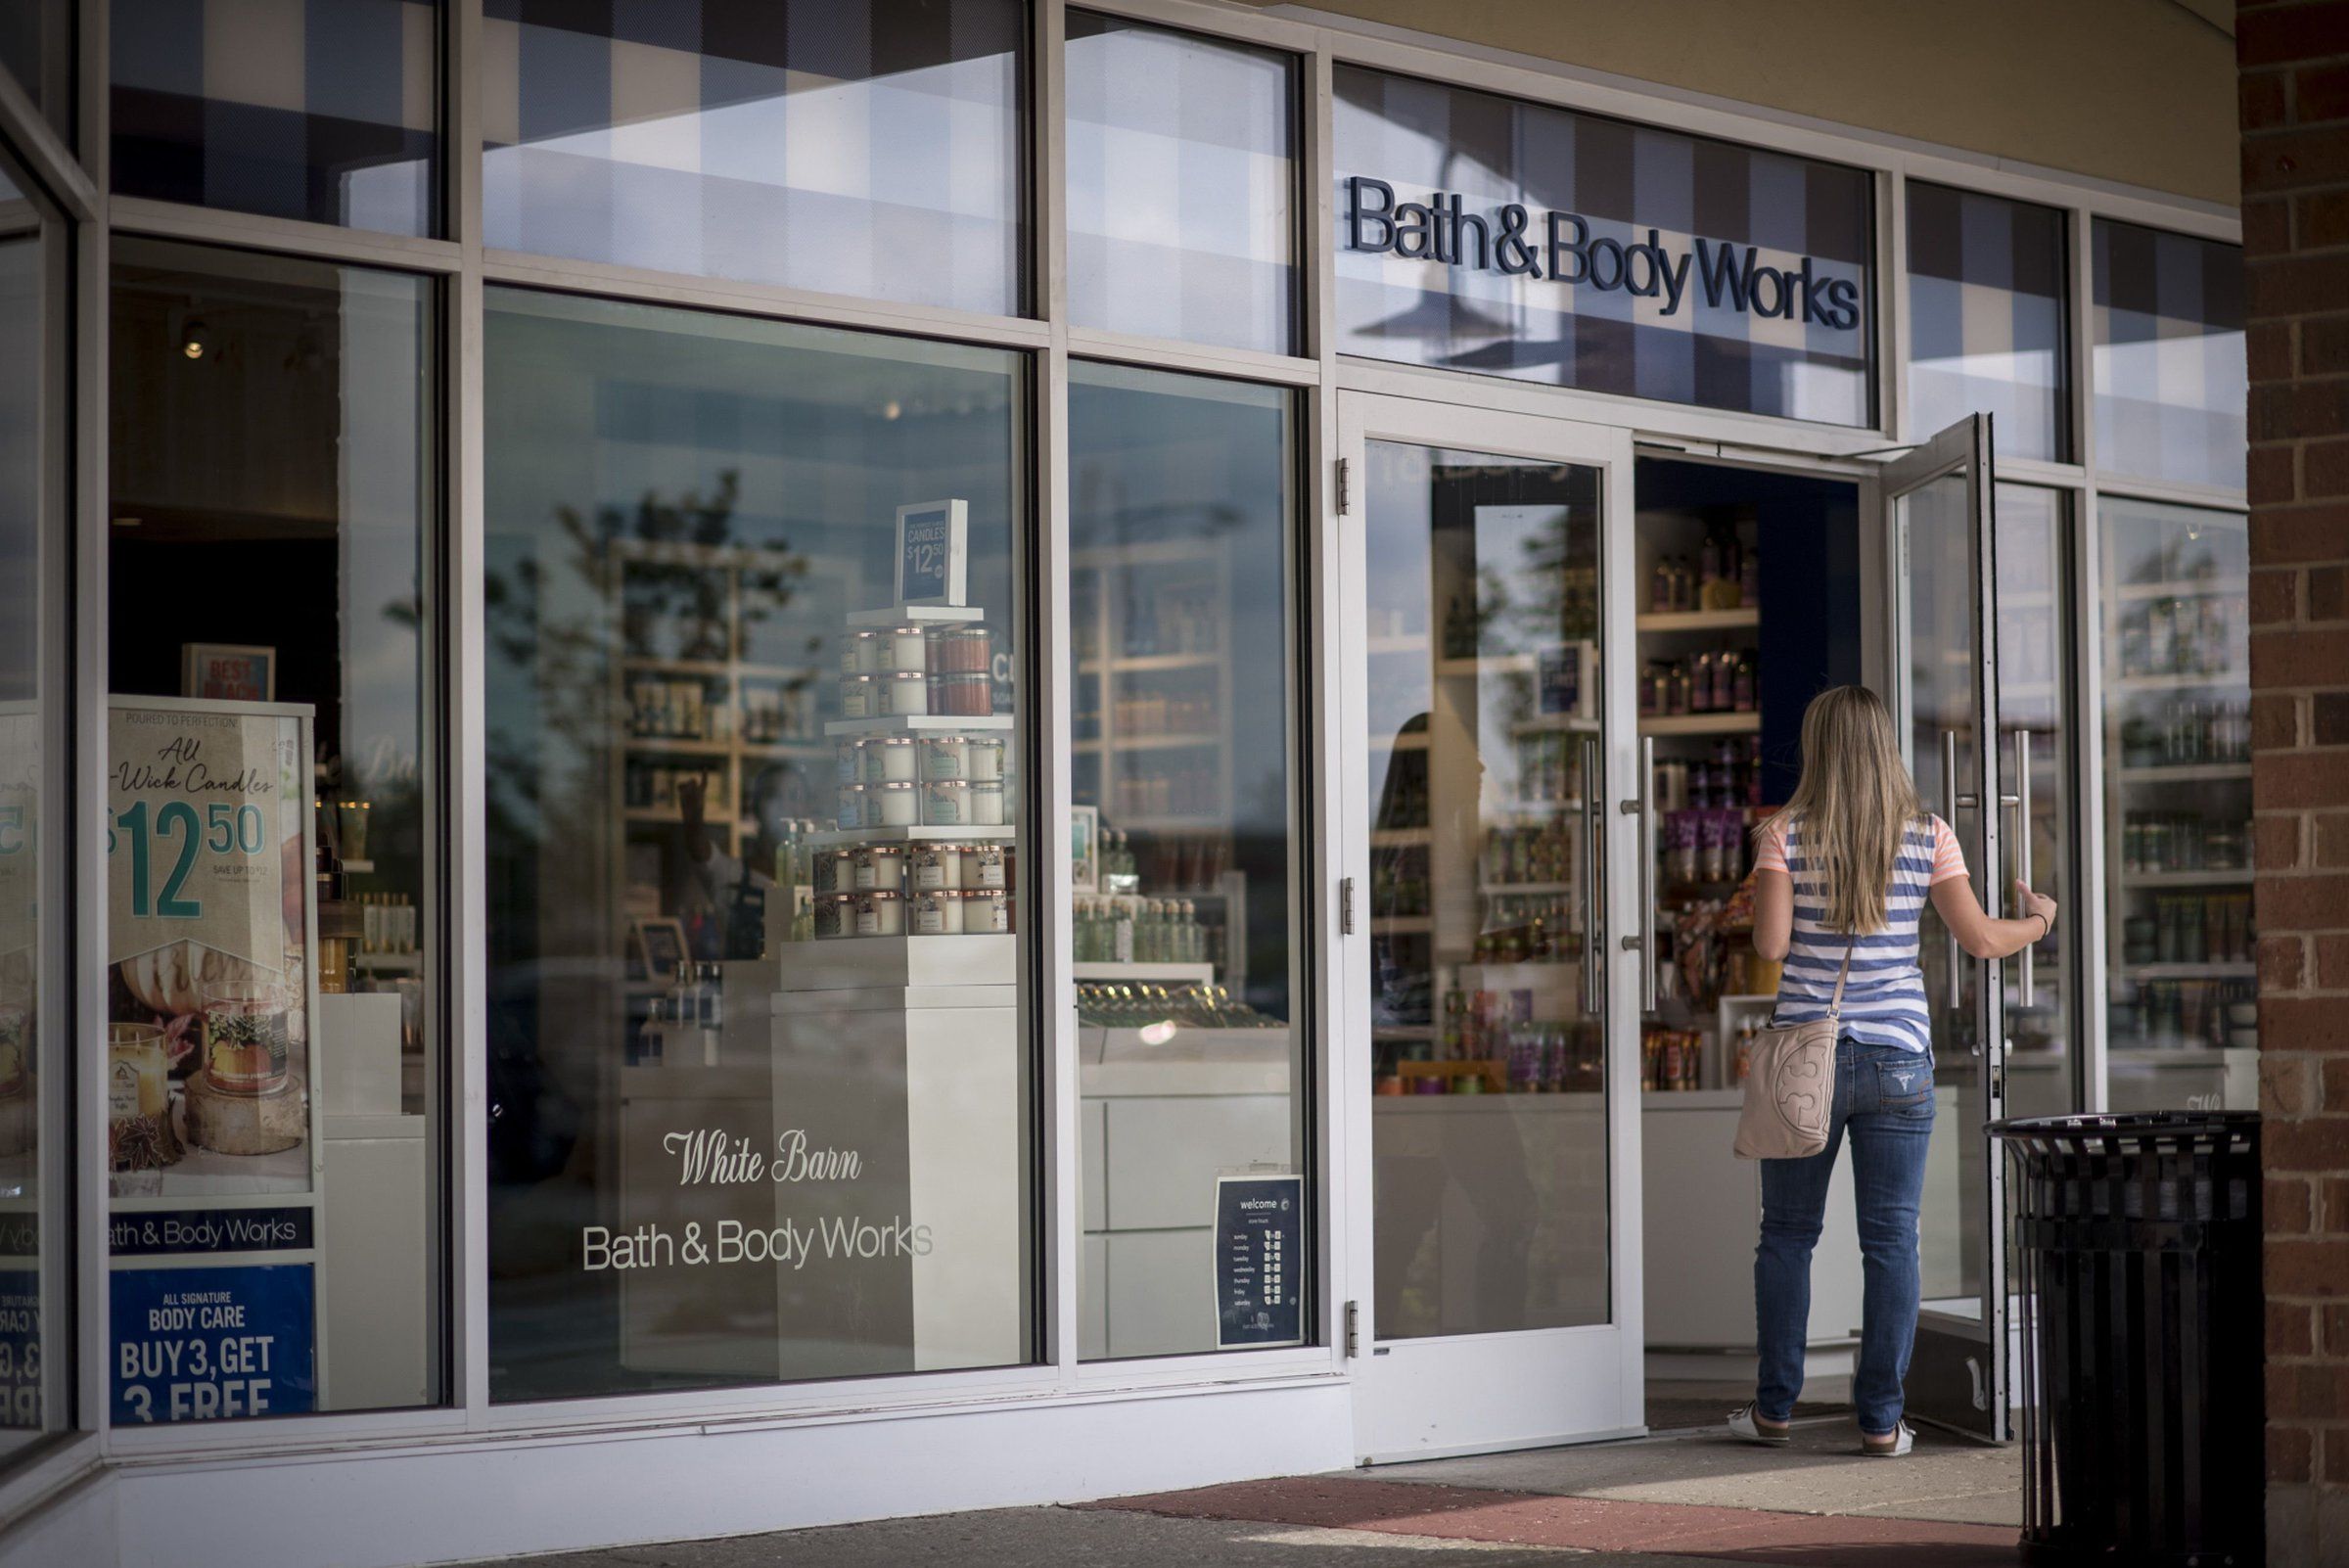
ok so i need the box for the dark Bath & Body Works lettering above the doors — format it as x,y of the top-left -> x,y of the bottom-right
1346,173 -> 1861,331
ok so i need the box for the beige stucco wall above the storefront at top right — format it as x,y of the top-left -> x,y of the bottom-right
1247,0 -> 2238,207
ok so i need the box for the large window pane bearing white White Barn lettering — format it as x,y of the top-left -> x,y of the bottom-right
480,289 -> 1034,1402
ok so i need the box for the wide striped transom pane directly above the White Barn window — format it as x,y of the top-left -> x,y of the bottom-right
482,0 -> 1027,314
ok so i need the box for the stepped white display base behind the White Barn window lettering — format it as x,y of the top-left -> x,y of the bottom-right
621,986 -> 1024,1378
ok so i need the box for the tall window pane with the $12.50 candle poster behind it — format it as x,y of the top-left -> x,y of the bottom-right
104,240 -> 448,1425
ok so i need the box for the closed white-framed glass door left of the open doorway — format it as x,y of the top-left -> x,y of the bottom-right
1339,396 -> 1651,1460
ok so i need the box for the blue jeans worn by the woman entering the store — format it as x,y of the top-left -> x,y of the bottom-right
1755,1036 -> 1933,1434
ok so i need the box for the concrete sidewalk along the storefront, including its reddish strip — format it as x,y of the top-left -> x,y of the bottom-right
490,1418 -> 2020,1568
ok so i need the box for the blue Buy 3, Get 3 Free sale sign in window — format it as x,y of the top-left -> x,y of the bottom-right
113,1263 -> 317,1425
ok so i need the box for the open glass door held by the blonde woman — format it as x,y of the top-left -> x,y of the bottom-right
1881,415 -> 2030,1441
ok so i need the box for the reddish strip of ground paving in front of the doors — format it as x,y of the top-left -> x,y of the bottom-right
1082,1476 -> 2020,1568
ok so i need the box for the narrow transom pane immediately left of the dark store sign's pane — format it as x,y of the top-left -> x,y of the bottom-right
1064,12 -> 1297,354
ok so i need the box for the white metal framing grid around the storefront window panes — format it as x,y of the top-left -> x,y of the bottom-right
0,0 -> 2245,1523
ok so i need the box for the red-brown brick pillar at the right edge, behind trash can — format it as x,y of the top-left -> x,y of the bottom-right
2236,0 -> 2349,1563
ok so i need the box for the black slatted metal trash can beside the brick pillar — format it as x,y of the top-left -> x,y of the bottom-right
1990,1110 -> 2267,1568
